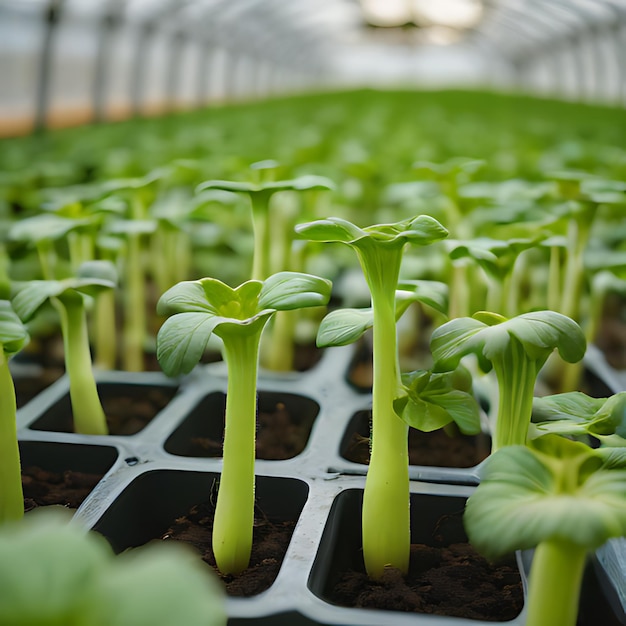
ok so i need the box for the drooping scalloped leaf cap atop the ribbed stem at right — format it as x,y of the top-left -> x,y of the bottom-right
430,311 -> 586,371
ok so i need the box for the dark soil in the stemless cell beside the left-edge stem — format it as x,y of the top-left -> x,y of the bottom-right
22,465 -> 104,512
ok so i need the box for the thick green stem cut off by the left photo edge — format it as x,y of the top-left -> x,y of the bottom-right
0,352 -> 24,525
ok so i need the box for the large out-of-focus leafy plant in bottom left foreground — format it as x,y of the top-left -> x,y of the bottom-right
0,507 -> 227,626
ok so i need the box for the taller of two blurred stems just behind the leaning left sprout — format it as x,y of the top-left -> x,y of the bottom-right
122,233 -> 146,372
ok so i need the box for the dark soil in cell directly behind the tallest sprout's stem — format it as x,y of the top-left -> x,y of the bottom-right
342,411 -> 491,468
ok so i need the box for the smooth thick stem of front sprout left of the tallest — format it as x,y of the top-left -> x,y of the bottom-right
213,332 -> 260,574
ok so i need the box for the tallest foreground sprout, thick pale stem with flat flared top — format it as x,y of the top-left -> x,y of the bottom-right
296,215 -> 448,579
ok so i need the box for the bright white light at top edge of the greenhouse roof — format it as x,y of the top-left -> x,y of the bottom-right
361,0 -> 483,29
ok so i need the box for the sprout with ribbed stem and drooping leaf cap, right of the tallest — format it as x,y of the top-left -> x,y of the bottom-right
430,311 -> 586,452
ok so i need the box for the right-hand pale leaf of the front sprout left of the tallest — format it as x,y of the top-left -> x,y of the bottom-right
259,272 -> 332,311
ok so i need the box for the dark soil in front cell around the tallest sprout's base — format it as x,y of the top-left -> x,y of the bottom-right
328,515 -> 524,621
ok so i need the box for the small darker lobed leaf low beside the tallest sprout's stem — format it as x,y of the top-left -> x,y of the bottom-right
394,370 -> 480,435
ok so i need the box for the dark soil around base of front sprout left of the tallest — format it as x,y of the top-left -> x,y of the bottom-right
162,501 -> 295,597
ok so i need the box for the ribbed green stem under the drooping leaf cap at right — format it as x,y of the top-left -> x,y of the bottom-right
491,336 -> 537,452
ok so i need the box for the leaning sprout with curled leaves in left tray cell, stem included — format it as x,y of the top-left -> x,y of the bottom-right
12,261 -> 117,435
